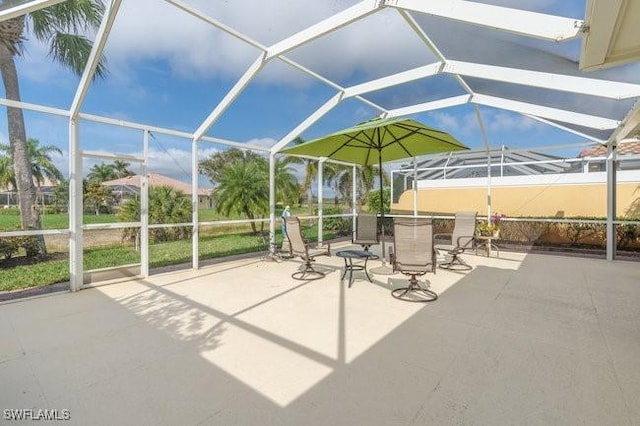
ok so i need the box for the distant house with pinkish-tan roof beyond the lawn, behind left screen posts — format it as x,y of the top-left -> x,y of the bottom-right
102,173 -> 213,209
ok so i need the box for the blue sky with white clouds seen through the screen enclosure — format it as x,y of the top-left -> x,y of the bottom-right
0,0 -> 640,190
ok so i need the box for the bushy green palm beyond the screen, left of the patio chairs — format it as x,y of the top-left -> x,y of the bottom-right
216,161 -> 269,233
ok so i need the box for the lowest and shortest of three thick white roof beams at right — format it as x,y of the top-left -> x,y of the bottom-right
471,94 -> 620,130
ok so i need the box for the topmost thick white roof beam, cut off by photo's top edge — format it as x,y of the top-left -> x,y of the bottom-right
386,0 -> 583,41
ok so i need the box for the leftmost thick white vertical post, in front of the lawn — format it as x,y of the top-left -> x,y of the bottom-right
69,119 -> 84,291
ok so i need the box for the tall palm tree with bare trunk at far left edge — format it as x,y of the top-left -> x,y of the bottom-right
0,0 -> 106,254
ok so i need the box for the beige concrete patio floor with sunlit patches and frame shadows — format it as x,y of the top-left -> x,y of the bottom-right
0,245 -> 640,425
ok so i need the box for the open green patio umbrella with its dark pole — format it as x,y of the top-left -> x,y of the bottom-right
281,118 -> 469,270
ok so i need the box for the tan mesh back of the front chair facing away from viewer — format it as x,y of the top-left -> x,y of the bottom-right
393,218 -> 435,272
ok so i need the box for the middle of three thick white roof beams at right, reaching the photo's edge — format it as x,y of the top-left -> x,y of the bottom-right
443,61 -> 640,99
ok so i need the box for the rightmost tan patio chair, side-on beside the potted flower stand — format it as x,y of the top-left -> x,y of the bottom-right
434,212 -> 478,270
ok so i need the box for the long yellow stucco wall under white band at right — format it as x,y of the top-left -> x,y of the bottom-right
391,183 -> 640,218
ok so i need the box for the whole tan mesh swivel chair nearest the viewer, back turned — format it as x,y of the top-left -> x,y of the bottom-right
390,218 -> 438,302
